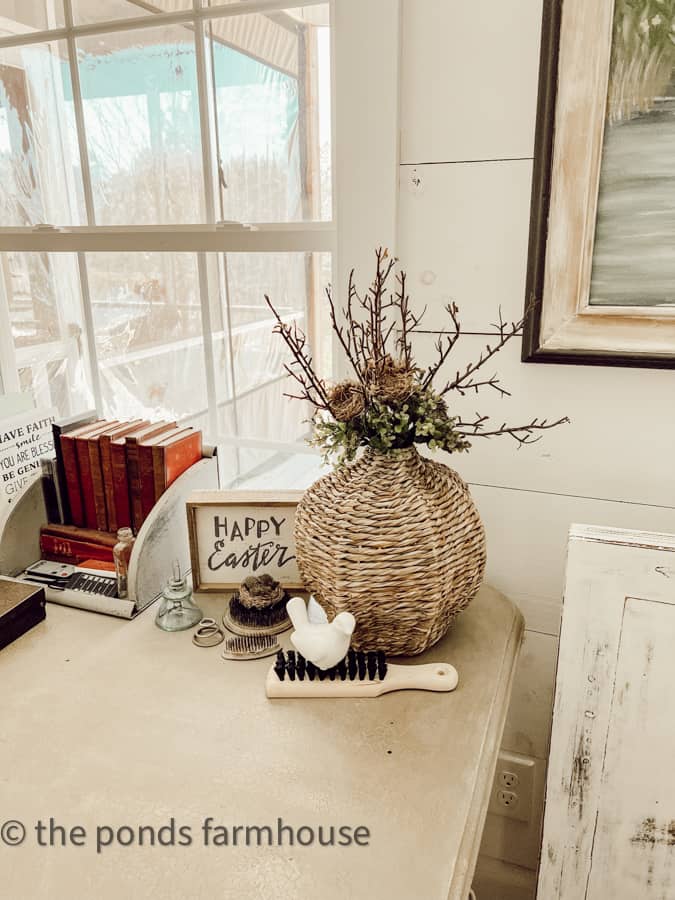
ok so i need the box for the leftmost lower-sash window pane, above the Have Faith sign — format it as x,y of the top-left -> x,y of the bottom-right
0,253 -> 93,416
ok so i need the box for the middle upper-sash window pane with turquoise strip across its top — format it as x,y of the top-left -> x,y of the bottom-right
78,25 -> 204,225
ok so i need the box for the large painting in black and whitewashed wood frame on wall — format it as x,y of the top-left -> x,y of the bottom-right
523,0 -> 675,368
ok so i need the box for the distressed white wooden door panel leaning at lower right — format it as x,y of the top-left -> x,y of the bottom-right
538,526 -> 675,900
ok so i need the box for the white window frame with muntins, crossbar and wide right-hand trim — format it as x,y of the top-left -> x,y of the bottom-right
0,0 -> 400,458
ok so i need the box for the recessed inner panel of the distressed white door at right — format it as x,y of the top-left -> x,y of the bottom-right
588,591 -> 675,900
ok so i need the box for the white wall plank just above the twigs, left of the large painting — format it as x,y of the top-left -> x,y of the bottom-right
398,160 -> 532,332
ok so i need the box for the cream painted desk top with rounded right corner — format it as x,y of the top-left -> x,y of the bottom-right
0,587 -> 522,900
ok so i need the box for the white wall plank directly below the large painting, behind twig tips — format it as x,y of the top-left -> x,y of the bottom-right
416,335 -> 675,506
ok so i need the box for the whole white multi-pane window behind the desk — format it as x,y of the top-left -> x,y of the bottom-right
0,0 -> 335,486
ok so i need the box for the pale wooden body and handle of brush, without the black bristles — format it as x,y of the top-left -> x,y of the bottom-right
265,663 -> 459,698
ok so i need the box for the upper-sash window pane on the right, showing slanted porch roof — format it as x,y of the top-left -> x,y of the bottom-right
206,5 -> 331,222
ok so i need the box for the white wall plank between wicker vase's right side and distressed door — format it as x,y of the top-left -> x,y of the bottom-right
468,482 -> 675,635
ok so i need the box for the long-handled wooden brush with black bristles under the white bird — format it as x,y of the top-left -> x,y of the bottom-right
265,650 -> 459,697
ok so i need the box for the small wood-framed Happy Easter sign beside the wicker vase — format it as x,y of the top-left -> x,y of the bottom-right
187,491 -> 304,591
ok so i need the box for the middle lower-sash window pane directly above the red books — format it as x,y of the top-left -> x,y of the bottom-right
87,253 -> 208,419
